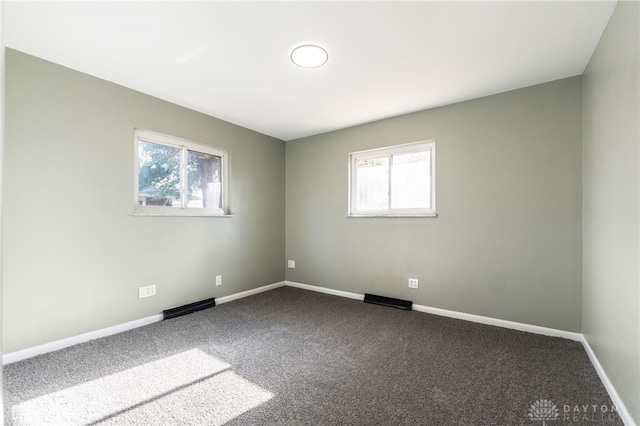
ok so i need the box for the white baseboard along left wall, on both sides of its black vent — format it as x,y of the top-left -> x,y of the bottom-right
2,281 -> 285,365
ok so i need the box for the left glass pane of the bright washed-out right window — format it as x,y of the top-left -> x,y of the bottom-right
356,157 -> 389,210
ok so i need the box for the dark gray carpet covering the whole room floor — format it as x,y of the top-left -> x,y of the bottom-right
4,287 -> 622,426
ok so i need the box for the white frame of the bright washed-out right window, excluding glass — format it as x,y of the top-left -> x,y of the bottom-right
347,139 -> 437,217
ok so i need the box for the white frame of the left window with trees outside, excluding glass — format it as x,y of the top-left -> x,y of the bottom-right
133,129 -> 232,217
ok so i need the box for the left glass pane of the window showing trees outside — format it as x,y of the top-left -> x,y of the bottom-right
138,141 -> 180,207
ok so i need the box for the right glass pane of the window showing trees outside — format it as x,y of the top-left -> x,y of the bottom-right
187,151 -> 222,209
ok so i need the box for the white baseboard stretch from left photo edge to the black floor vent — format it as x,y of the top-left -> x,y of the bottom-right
2,314 -> 162,365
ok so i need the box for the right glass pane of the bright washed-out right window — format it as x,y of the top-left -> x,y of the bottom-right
391,151 -> 431,209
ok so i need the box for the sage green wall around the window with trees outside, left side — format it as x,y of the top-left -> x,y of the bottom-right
2,50 -> 285,353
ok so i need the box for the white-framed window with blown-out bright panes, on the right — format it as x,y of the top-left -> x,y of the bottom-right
349,141 -> 436,216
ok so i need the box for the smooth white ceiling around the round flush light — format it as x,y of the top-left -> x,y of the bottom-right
2,1 -> 616,140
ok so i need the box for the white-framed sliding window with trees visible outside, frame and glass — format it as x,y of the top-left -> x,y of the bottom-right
135,130 -> 228,216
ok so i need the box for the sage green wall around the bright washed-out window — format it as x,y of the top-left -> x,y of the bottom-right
286,77 -> 582,332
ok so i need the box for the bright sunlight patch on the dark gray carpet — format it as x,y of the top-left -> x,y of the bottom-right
12,349 -> 273,425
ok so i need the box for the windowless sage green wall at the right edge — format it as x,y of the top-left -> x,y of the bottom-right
582,1 -> 640,424
